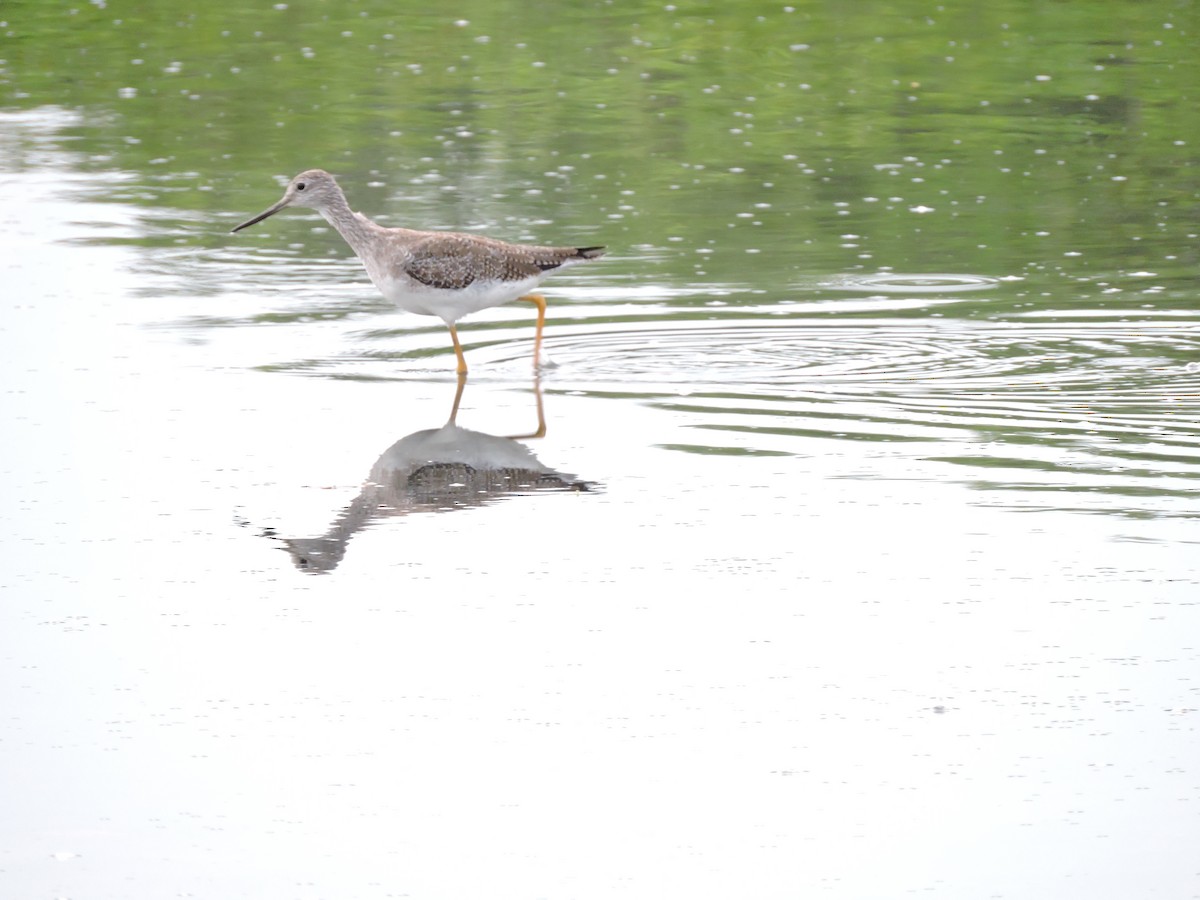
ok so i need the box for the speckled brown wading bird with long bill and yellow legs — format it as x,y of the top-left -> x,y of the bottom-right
233,169 -> 605,374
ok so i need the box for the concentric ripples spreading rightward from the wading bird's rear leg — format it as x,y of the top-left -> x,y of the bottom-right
511,319 -> 1200,516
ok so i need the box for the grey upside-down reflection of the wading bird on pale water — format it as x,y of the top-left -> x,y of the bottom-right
265,377 -> 595,572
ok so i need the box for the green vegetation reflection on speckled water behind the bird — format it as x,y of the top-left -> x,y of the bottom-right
0,0 -> 1200,284
